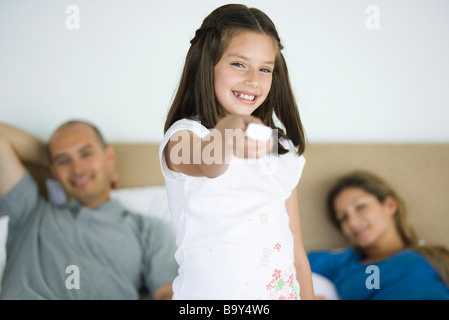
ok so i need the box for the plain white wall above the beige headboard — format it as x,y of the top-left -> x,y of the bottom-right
0,0 -> 449,142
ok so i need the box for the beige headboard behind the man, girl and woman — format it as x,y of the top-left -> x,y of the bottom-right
31,143 -> 449,250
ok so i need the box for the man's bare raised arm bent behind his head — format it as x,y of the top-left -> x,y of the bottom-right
0,123 -> 49,197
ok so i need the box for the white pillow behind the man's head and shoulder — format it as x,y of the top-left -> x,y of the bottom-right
46,179 -> 171,223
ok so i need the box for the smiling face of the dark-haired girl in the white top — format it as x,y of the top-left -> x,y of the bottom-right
214,31 -> 276,115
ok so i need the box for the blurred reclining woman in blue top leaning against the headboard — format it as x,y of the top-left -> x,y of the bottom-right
308,171 -> 449,300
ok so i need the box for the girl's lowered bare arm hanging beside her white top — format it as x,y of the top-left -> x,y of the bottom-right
285,188 -> 315,300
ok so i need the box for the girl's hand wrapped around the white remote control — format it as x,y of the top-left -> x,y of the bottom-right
215,115 -> 273,158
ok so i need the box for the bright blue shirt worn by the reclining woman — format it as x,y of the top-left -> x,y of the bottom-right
308,249 -> 449,300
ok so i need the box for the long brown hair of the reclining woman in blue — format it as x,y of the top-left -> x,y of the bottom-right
327,171 -> 449,286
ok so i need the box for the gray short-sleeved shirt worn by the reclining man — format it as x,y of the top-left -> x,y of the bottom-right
0,173 -> 178,299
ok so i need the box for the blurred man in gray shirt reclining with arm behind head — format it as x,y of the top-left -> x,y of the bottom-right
0,121 -> 178,299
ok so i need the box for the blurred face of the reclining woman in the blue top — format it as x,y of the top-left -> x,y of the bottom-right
334,187 -> 397,249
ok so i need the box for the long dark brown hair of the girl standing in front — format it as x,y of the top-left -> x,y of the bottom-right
164,4 -> 306,155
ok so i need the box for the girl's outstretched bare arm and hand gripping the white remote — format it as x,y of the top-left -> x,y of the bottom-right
164,115 -> 273,178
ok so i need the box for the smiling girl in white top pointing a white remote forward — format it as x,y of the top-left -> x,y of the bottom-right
159,4 -> 313,299
